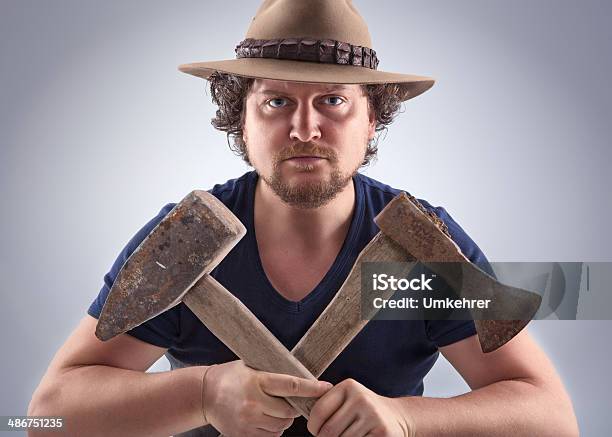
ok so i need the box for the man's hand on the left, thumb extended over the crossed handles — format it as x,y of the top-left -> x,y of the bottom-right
204,360 -> 332,437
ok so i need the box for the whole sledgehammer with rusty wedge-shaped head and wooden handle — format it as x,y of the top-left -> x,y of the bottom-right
96,190 -> 316,417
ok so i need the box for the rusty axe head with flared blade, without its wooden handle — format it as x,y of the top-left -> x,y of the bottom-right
374,193 -> 542,352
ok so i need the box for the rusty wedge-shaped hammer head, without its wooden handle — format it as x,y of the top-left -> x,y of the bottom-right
96,190 -> 246,341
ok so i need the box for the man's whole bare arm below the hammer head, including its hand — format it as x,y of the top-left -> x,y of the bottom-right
28,316 -> 331,437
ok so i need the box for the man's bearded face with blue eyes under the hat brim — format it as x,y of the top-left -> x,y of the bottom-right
243,79 -> 375,208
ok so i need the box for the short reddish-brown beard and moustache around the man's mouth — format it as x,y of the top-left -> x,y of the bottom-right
258,143 -> 365,209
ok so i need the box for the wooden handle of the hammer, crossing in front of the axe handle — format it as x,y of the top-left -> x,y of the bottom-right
183,275 -> 316,419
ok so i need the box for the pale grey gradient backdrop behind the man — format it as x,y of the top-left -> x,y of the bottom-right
0,0 -> 612,436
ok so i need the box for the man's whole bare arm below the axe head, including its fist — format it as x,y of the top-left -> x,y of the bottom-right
308,332 -> 578,437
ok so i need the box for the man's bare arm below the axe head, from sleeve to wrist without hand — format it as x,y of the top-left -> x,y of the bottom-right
398,331 -> 578,436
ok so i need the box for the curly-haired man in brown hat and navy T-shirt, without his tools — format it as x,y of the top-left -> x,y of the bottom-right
29,0 -> 577,436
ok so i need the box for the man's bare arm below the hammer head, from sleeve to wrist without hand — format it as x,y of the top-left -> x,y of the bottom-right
28,315 -> 205,437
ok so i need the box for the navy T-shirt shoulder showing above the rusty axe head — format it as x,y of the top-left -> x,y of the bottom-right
357,173 -> 493,274
